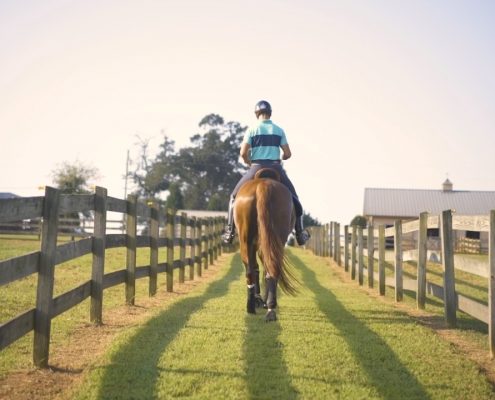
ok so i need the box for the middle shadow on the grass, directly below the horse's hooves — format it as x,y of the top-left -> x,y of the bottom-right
244,311 -> 298,400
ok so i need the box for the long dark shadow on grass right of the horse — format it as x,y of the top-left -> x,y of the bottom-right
291,255 -> 429,400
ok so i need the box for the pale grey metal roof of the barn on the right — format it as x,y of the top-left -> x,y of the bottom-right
364,188 -> 495,217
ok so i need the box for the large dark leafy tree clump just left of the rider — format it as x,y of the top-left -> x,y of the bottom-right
131,114 -> 247,210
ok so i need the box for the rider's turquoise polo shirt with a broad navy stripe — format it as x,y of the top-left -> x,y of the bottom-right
243,119 -> 287,161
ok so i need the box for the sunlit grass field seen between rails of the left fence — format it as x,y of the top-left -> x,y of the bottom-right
0,237 -> 204,377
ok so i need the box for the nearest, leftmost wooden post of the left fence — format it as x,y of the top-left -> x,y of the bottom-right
33,187 -> 60,368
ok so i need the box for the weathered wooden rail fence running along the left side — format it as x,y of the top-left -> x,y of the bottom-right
0,187 -> 224,367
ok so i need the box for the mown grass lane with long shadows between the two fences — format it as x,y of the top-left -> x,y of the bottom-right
70,249 -> 495,400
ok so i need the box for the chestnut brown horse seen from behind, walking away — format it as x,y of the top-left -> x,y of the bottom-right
234,168 -> 296,321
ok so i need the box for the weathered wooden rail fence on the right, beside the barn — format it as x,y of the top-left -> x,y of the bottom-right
308,210 -> 495,358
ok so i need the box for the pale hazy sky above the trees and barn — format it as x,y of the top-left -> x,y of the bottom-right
0,0 -> 495,223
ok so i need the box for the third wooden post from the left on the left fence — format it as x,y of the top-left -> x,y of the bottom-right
125,195 -> 137,305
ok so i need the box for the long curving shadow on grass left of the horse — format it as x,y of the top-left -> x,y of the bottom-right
97,255 -> 242,399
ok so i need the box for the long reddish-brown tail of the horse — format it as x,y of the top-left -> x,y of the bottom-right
256,183 -> 297,295
